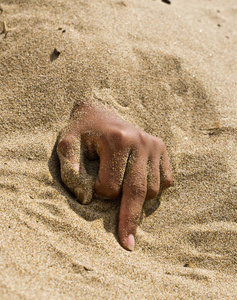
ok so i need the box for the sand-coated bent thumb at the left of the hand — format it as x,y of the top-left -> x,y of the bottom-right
57,133 -> 93,204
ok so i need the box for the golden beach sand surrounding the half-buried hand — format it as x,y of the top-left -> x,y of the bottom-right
0,0 -> 237,299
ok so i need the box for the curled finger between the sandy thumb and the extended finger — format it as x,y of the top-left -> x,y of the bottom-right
95,147 -> 128,199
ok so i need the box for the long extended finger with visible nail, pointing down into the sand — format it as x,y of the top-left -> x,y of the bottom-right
118,155 -> 147,251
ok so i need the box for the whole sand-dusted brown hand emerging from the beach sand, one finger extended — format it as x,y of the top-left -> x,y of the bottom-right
57,100 -> 172,251
